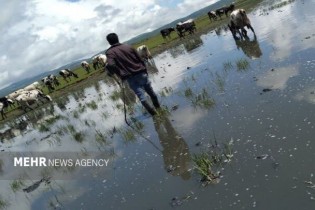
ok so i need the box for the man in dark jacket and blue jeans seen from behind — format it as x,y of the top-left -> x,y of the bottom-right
106,33 -> 160,115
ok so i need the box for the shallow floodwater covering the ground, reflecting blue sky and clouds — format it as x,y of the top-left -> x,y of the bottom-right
0,1 -> 315,210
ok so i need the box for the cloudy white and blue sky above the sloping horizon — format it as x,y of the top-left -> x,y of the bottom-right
0,0 -> 219,89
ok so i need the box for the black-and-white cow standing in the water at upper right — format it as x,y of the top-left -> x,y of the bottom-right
228,9 -> 255,39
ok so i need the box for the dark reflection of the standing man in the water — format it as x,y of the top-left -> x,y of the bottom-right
154,117 -> 190,180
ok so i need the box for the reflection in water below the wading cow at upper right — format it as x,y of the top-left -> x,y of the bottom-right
234,35 -> 262,59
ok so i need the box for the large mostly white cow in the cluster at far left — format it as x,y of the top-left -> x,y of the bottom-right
16,90 -> 52,112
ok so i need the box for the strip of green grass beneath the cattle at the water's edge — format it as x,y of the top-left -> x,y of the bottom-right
0,0 -> 263,120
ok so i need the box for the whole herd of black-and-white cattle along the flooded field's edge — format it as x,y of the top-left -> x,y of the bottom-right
0,4 -> 255,119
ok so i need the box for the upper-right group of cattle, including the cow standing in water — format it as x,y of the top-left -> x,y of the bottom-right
160,4 -> 255,40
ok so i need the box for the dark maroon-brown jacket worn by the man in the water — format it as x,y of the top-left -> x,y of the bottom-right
106,43 -> 147,79
